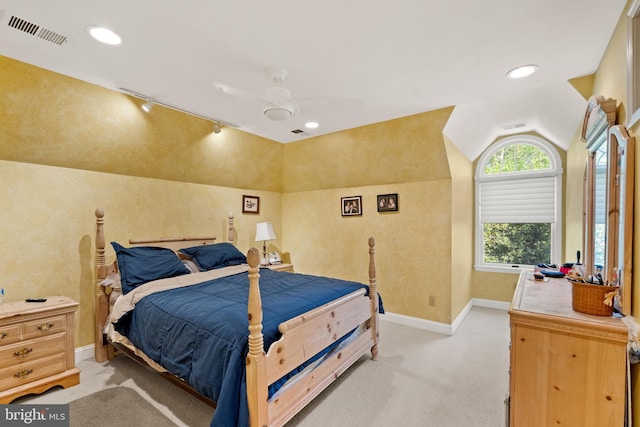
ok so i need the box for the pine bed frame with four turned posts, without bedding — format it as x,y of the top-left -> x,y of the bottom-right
95,208 -> 379,427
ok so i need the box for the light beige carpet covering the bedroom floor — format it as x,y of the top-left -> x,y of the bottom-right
20,307 -> 509,427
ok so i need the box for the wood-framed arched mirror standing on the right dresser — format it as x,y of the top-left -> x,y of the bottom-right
582,96 -> 635,315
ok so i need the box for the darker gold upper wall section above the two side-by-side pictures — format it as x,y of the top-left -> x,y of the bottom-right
283,108 -> 453,193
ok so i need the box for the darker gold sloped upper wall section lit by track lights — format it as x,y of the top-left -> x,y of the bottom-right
0,57 -> 282,191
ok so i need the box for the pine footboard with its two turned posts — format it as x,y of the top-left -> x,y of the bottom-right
247,238 -> 378,427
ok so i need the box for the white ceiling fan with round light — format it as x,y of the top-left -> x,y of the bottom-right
216,68 -> 300,122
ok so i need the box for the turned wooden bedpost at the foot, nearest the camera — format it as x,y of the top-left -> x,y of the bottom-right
246,248 -> 269,427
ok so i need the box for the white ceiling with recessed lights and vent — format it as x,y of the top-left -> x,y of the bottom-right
0,0 -> 626,160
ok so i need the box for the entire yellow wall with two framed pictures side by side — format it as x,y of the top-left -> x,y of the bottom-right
282,108 -> 458,323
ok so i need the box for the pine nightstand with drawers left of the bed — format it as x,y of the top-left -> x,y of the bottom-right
0,296 -> 80,404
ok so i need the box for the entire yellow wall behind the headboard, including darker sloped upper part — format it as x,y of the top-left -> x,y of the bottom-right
0,57 -> 282,346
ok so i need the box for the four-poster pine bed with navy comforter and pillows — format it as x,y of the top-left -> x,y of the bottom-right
95,208 -> 383,427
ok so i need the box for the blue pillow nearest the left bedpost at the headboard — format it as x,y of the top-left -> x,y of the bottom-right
111,242 -> 190,294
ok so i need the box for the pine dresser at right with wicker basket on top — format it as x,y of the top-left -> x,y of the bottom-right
509,271 -> 627,427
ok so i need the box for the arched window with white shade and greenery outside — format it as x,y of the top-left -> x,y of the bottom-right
476,135 -> 562,272
